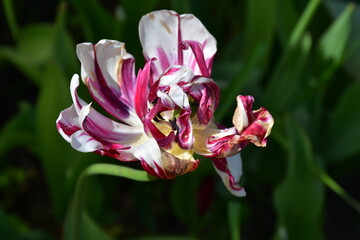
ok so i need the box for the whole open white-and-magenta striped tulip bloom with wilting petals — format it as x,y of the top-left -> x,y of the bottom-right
56,10 -> 274,196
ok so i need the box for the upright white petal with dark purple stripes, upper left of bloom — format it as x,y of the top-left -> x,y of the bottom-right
77,40 -> 141,125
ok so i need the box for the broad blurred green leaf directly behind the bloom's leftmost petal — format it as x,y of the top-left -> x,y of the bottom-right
36,61 -> 81,218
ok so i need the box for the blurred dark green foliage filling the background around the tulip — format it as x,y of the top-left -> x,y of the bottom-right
0,0 -> 360,240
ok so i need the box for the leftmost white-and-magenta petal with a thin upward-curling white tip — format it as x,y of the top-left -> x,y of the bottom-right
56,75 -> 146,161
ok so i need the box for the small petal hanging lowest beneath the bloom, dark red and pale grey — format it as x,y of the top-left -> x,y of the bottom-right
212,154 -> 246,197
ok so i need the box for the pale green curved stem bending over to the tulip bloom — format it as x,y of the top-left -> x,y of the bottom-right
65,163 -> 157,240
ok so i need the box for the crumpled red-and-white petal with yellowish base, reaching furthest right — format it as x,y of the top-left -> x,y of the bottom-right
194,96 -> 274,158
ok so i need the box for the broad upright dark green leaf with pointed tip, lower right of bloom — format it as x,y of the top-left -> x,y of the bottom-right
274,116 -> 325,240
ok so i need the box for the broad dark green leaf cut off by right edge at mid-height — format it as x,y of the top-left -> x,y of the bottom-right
323,82 -> 360,163
